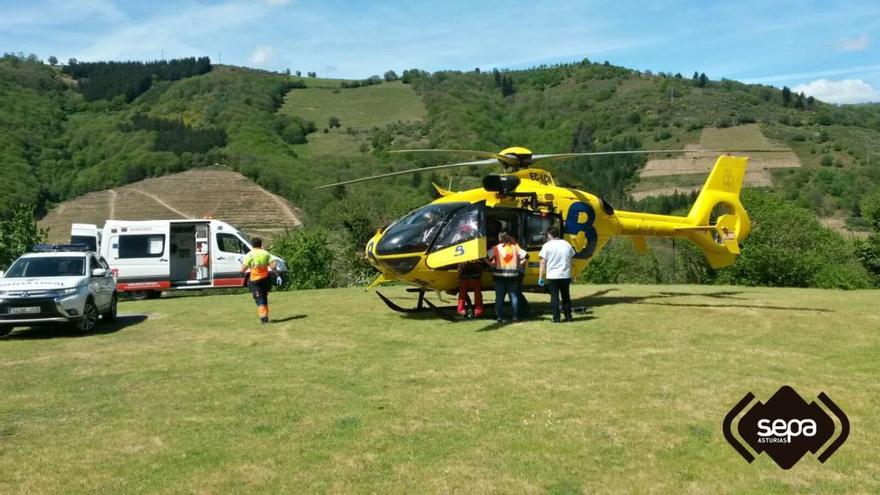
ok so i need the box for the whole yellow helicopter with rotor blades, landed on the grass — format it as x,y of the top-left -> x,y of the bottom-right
319,147 -> 764,312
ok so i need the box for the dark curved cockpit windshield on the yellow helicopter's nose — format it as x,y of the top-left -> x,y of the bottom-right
376,202 -> 468,256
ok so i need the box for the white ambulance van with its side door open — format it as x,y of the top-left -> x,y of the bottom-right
70,219 -> 287,298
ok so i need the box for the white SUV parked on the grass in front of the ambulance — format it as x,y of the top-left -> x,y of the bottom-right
0,245 -> 118,336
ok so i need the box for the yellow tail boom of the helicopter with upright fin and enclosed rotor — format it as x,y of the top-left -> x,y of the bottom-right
618,155 -> 751,268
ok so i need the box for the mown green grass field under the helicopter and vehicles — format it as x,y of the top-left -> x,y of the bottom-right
0,286 -> 880,494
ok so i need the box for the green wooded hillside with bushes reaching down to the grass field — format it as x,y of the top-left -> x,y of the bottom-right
0,54 -> 880,287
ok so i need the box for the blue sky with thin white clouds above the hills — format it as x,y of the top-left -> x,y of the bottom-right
0,0 -> 880,103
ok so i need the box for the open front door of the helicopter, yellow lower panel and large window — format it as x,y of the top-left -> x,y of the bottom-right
425,201 -> 486,269
